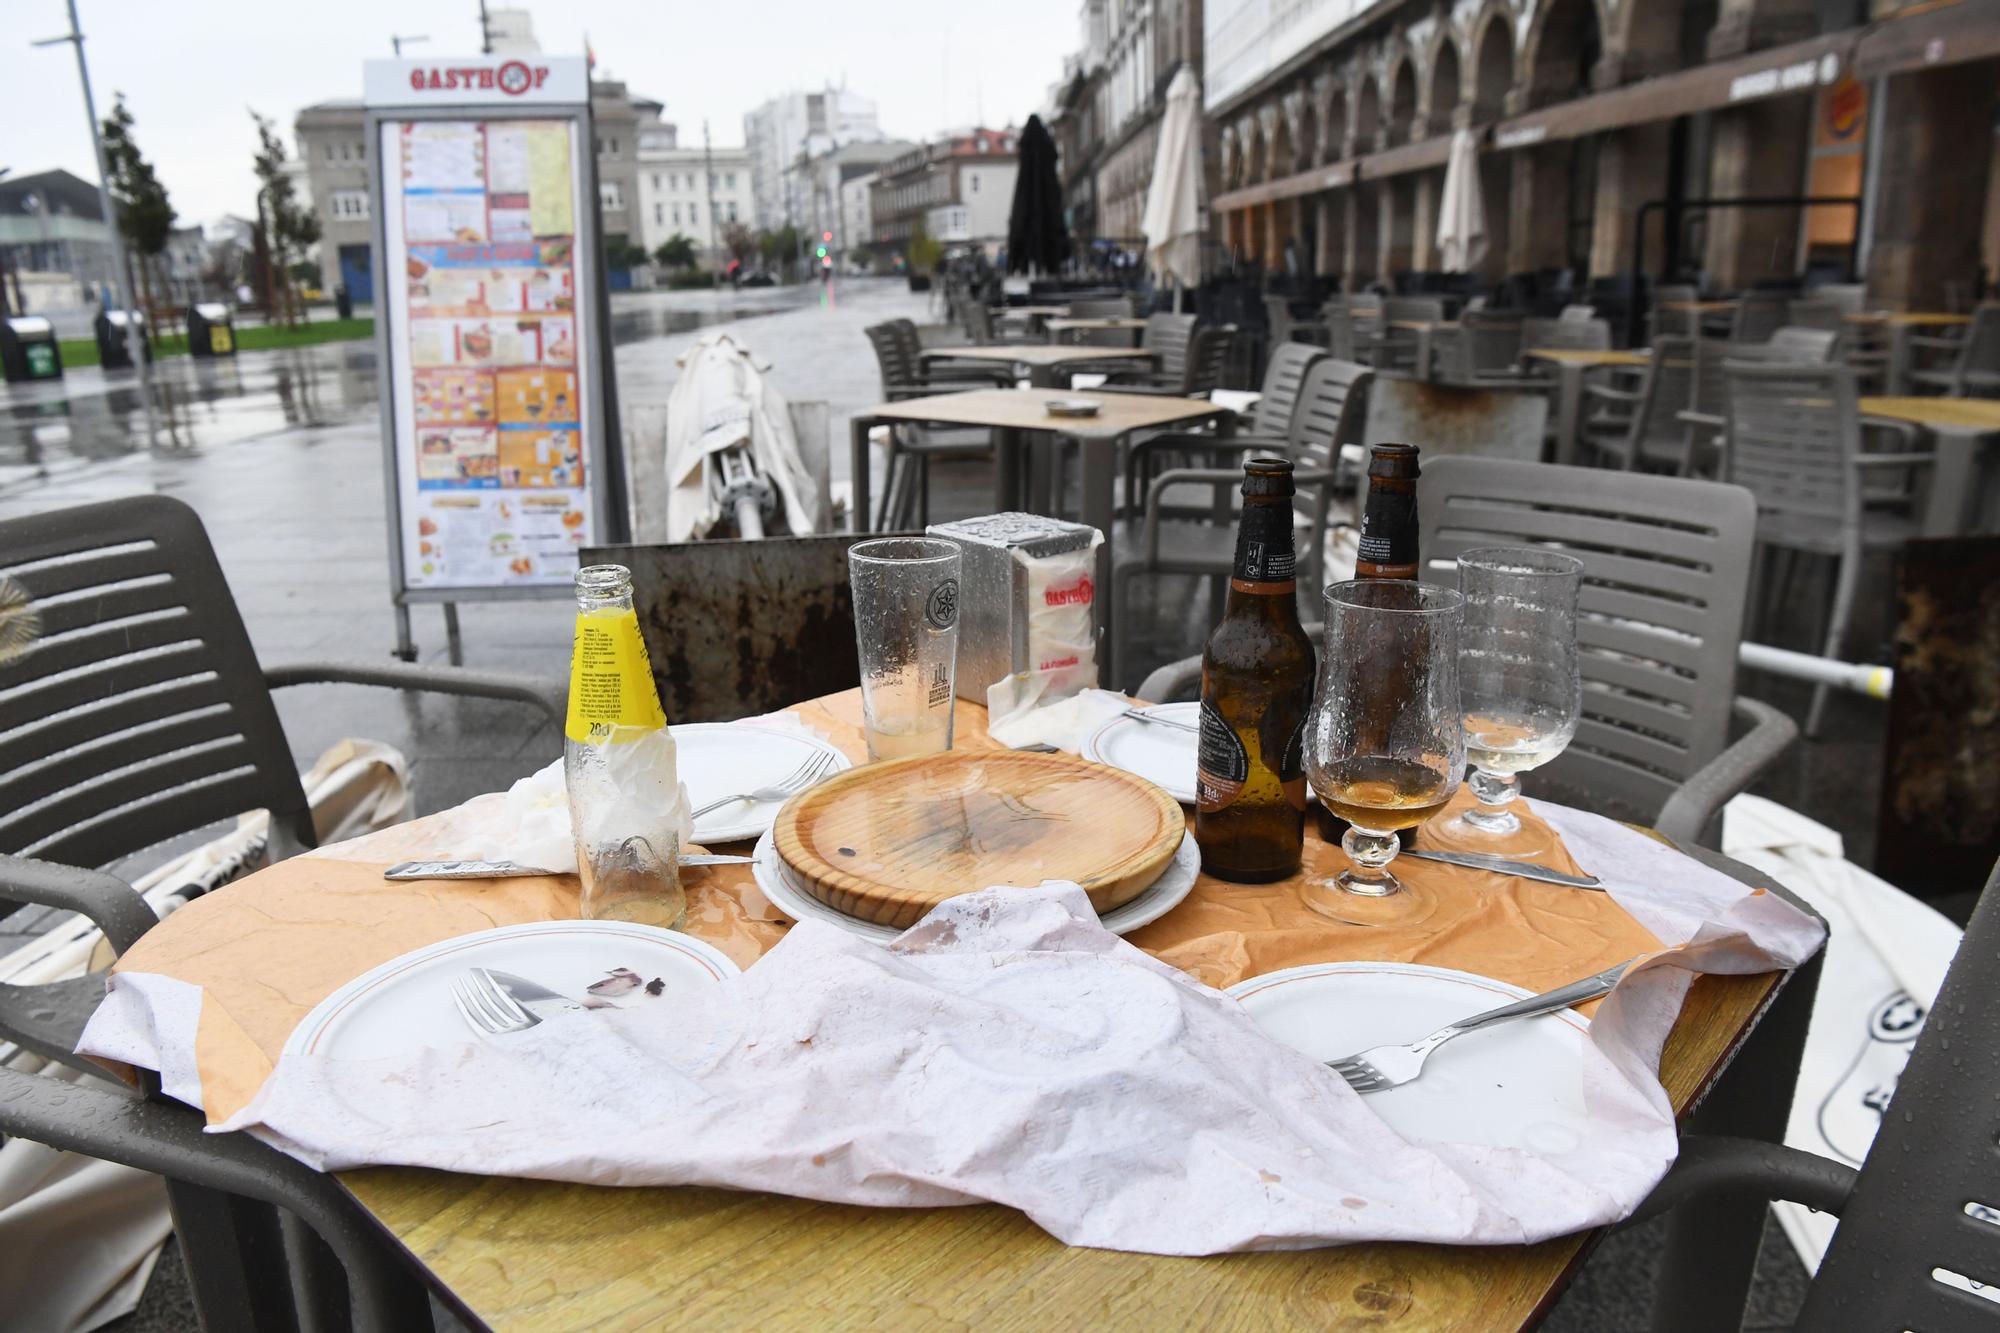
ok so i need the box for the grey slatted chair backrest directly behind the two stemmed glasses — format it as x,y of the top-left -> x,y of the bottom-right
1418,458 -> 1756,821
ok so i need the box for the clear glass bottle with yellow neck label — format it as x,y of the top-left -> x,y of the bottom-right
562,564 -> 688,929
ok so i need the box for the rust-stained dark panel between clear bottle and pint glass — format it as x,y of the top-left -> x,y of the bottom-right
584,534 -> 870,723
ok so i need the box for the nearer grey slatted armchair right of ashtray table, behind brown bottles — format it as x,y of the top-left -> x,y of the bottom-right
1112,358 -> 1374,671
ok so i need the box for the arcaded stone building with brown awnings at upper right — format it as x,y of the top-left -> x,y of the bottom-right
1204,0 -> 2000,304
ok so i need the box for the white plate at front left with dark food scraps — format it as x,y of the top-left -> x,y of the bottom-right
284,921 -> 742,1059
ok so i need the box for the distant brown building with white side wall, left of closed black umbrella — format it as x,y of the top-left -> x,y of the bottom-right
868,128 -> 1020,254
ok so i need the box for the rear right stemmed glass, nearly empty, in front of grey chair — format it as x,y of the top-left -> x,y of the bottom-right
1434,546 -> 1584,844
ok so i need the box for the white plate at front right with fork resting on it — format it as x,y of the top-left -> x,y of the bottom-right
1228,963 -> 1590,1157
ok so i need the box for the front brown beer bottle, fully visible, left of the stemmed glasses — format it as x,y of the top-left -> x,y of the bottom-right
1194,458 -> 1314,885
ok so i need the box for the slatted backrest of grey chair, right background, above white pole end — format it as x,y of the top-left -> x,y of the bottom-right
1722,360 -> 1860,528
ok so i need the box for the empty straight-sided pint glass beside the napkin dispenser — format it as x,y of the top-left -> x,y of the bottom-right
848,536 -> 958,759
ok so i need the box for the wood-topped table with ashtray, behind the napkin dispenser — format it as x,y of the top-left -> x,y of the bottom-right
848,384 -> 1234,681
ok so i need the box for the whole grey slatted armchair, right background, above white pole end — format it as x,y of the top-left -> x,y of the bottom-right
1722,360 -> 1934,737
